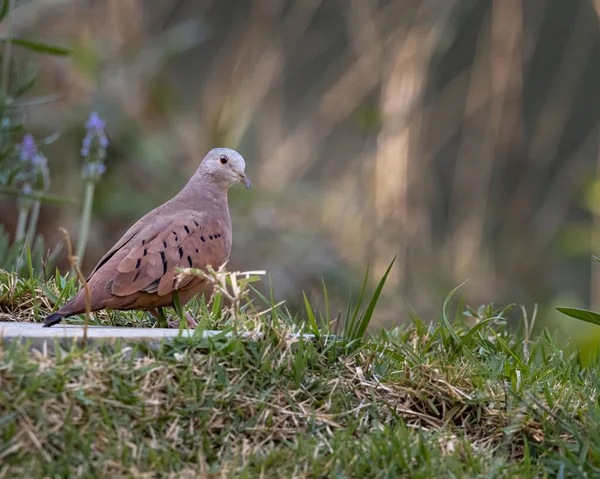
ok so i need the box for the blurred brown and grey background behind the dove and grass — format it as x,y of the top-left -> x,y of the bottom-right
0,0 -> 600,332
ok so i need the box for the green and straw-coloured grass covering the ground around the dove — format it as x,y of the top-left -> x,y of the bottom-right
0,273 -> 600,477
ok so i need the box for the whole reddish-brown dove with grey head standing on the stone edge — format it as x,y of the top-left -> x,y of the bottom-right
44,148 -> 251,328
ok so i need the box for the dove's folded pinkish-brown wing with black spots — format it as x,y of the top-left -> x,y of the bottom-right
108,210 -> 231,296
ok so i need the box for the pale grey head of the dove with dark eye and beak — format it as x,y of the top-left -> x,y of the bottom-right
198,148 -> 252,189
